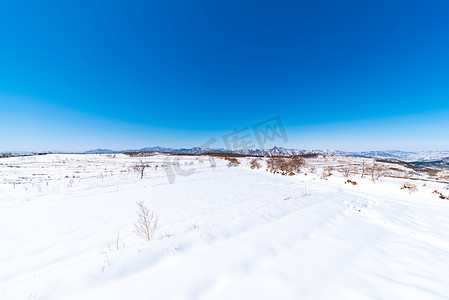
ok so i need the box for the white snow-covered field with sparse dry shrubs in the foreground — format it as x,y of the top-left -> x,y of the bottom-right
0,154 -> 449,300
